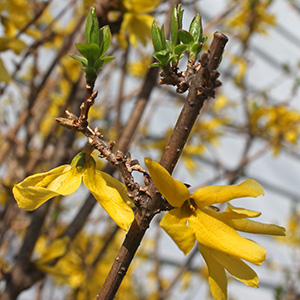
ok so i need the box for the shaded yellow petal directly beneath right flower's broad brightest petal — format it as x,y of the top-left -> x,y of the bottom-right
205,249 -> 259,288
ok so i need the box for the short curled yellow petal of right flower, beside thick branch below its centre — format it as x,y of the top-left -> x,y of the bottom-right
159,208 -> 196,255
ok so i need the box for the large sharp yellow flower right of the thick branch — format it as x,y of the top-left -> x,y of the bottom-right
145,158 -> 285,300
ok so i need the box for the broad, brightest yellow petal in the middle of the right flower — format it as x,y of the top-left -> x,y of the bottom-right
189,208 -> 266,265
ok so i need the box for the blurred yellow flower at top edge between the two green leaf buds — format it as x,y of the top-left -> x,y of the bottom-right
120,0 -> 160,47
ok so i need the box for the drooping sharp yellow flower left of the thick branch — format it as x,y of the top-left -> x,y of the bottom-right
13,152 -> 134,230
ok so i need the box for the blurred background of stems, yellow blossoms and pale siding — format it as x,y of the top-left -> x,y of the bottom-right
0,0 -> 300,300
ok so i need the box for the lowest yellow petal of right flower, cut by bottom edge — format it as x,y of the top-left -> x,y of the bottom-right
198,244 -> 227,300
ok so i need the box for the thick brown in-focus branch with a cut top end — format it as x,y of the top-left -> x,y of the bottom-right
97,32 -> 228,300
